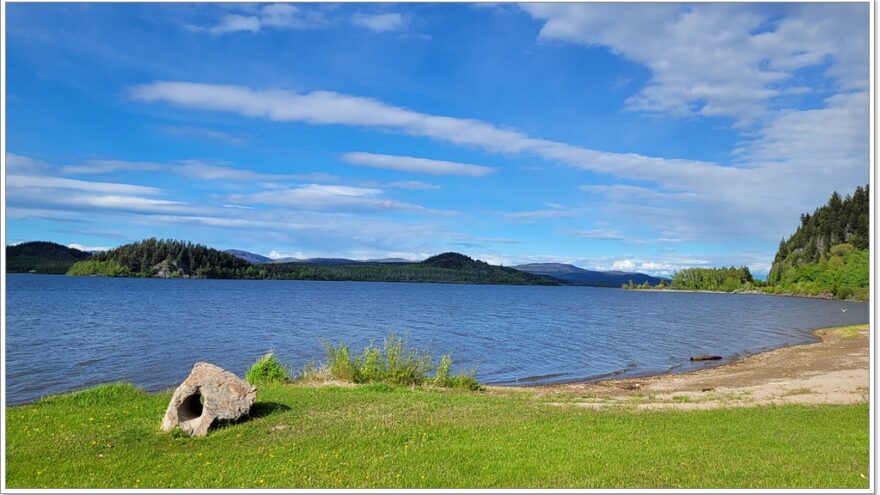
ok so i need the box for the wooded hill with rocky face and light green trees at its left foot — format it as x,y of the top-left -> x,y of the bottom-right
67,238 -> 251,278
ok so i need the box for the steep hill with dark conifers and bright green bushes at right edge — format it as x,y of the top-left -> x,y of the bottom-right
766,185 -> 870,299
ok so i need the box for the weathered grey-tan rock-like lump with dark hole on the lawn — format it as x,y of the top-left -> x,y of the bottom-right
162,363 -> 257,437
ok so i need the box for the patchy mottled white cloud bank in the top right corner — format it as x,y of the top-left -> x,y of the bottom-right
523,3 -> 868,125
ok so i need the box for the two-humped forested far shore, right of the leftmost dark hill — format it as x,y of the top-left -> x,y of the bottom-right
67,239 -> 560,285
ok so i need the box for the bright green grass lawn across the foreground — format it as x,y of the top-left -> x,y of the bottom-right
6,385 -> 868,488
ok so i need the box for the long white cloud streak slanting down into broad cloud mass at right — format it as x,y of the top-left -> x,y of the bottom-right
131,77 -> 868,241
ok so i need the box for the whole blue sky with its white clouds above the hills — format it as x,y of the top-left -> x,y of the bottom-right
5,3 -> 869,275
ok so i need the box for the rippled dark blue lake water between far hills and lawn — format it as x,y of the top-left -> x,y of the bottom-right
5,274 -> 868,404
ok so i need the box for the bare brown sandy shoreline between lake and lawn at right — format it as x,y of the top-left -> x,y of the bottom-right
491,324 -> 870,410
